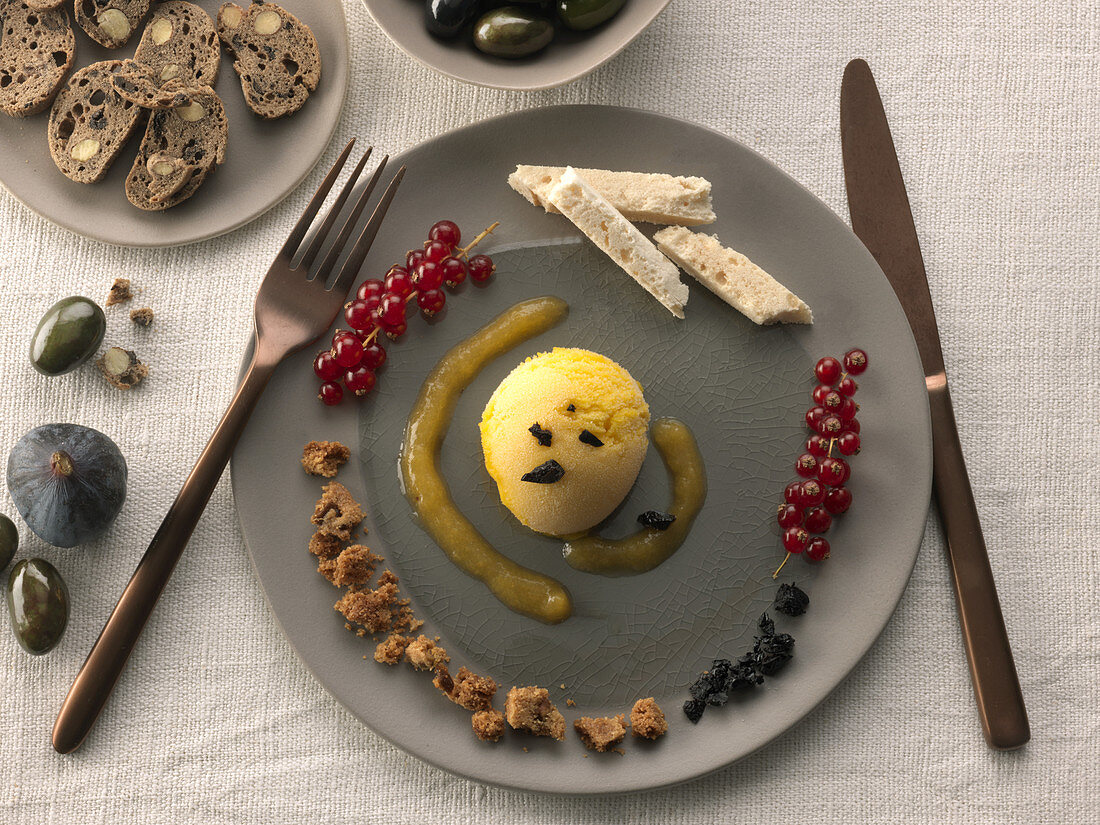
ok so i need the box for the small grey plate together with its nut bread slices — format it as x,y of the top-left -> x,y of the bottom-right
0,0 -> 349,246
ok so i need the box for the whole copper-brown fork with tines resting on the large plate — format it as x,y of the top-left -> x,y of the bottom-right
53,140 -> 405,754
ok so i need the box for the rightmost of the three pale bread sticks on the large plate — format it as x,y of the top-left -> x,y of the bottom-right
653,227 -> 814,325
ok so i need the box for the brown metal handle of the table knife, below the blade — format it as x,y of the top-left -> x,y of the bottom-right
927,373 -> 1031,750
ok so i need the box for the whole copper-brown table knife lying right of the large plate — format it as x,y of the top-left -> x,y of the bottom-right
840,59 -> 1031,750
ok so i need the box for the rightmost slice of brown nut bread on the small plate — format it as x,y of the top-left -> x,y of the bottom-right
218,0 -> 321,120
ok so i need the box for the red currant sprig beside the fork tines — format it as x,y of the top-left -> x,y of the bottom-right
314,220 -> 501,406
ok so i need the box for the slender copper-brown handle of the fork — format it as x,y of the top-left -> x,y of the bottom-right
52,348 -> 278,754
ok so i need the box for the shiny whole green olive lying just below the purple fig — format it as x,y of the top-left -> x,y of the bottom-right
8,559 -> 68,656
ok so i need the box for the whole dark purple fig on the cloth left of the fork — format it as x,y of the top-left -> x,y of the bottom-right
8,424 -> 127,547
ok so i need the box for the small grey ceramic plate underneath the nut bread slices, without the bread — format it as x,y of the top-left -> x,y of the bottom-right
0,0 -> 348,246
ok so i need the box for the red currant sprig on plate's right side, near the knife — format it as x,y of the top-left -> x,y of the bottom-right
771,350 -> 867,579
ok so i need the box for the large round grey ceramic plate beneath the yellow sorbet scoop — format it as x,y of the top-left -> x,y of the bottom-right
232,106 -> 932,793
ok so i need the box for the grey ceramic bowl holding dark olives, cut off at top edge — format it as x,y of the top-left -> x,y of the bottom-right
363,0 -> 670,91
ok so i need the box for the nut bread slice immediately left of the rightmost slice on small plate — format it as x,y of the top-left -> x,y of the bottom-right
134,0 -> 221,86
